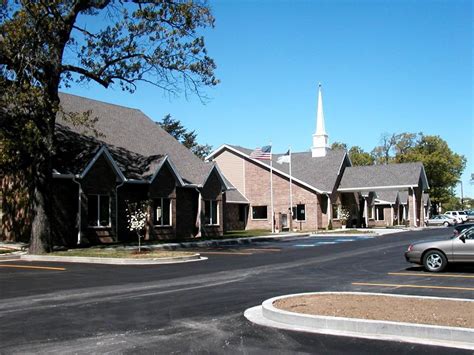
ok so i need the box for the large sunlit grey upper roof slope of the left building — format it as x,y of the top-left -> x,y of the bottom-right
57,93 -> 214,185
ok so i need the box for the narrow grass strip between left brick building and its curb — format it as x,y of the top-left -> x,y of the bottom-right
50,248 -> 195,259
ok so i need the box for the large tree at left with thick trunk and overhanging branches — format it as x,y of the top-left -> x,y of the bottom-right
0,0 -> 218,253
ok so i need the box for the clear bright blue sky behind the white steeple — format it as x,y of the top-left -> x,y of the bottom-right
65,0 -> 474,197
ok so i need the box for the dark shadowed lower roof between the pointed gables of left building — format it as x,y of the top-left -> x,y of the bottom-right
53,124 -> 164,180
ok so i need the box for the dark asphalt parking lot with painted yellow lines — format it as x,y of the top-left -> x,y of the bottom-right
0,229 -> 474,354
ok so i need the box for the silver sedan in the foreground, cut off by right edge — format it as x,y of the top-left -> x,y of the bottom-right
405,227 -> 474,272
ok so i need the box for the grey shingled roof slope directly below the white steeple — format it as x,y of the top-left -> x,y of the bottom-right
229,145 -> 346,192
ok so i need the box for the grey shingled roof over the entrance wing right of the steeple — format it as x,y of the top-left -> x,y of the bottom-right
339,163 -> 427,191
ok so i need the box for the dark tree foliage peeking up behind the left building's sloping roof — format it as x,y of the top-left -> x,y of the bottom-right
157,114 -> 212,159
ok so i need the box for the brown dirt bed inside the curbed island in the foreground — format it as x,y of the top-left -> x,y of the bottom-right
273,294 -> 474,328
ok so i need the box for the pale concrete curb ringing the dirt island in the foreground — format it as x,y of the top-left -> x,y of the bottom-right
244,292 -> 474,350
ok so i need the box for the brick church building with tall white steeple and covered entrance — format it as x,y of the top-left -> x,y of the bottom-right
207,86 -> 429,231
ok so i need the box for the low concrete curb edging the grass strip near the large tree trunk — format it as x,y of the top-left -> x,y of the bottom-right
21,254 -> 207,265
